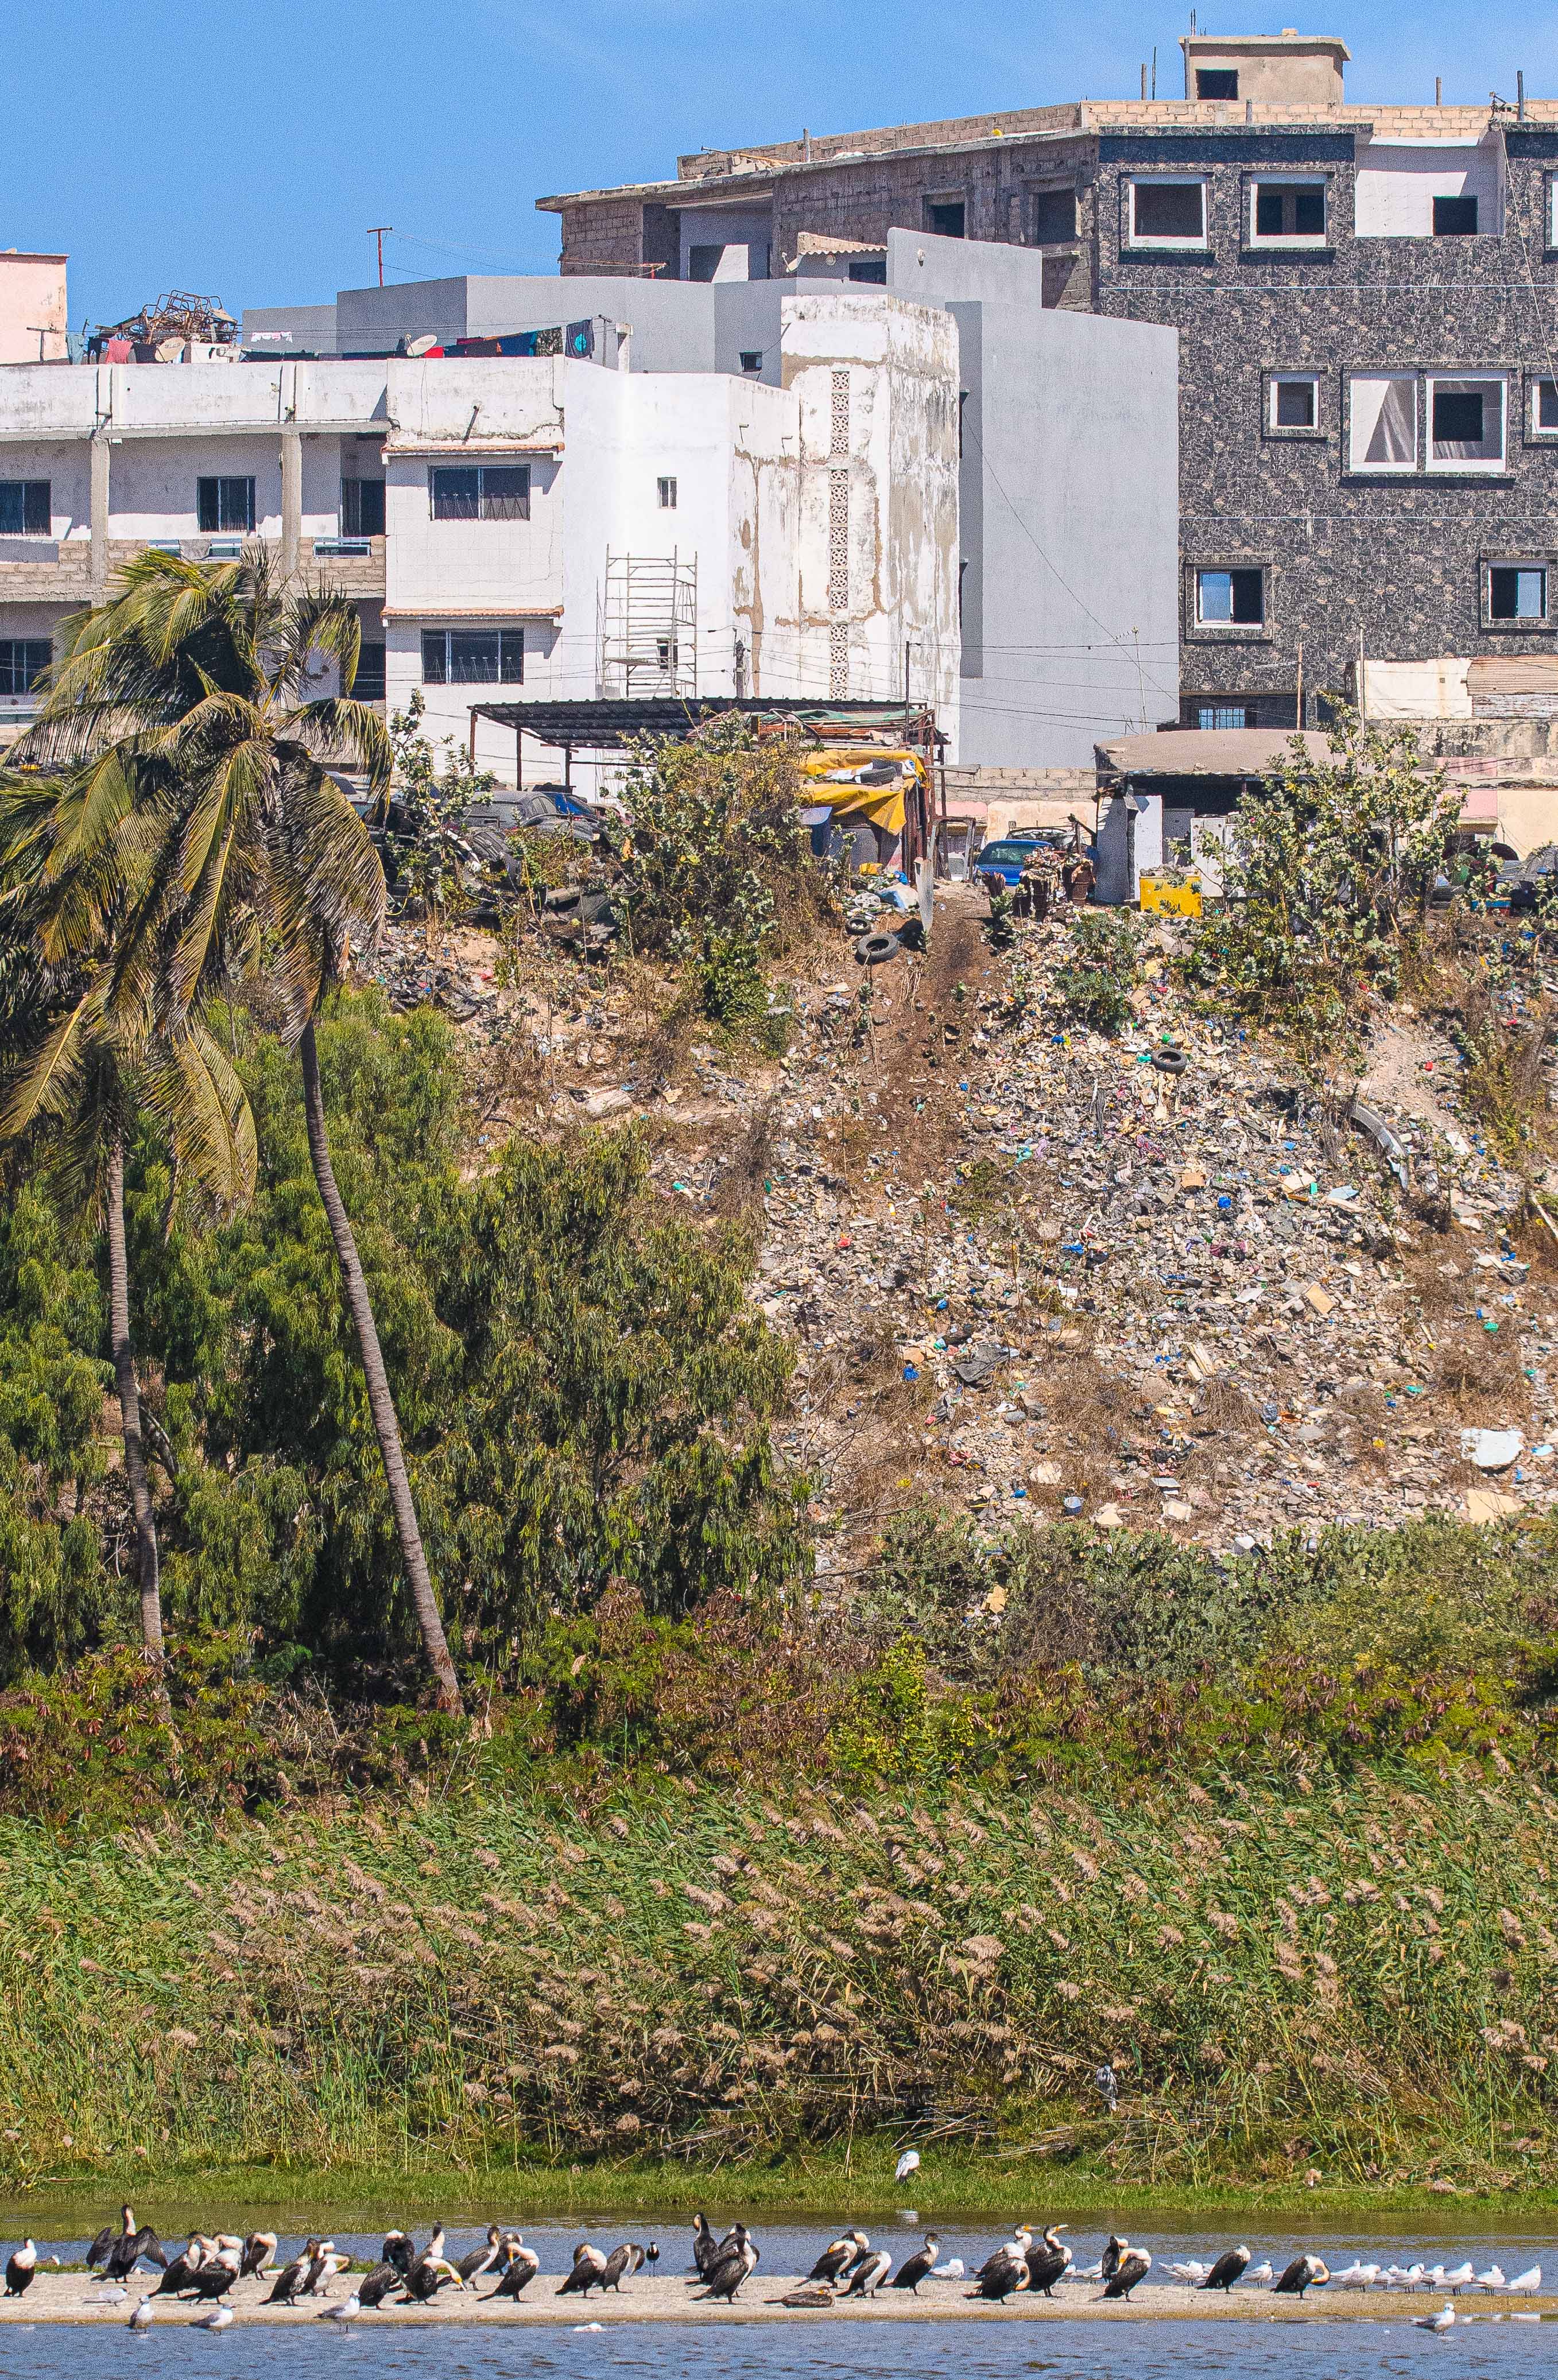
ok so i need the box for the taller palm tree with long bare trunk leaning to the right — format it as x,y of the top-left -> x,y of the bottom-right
17,552 -> 462,1711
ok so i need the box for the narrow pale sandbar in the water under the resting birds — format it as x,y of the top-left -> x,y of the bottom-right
0,2270 -> 1558,2330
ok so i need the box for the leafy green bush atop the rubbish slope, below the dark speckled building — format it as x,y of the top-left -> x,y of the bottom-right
1189,710 -> 1456,1069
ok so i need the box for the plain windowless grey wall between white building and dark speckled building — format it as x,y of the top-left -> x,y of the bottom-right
887,231 -> 1180,766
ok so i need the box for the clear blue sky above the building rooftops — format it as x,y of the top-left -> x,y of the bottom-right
0,0 -> 1558,326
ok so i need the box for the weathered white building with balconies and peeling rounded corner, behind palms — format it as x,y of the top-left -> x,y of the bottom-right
0,286 -> 959,783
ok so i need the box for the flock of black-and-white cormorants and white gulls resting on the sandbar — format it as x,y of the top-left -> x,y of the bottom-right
5,2206 -> 1541,2335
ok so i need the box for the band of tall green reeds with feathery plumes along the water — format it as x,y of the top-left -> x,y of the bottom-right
0,1776 -> 1558,2185
